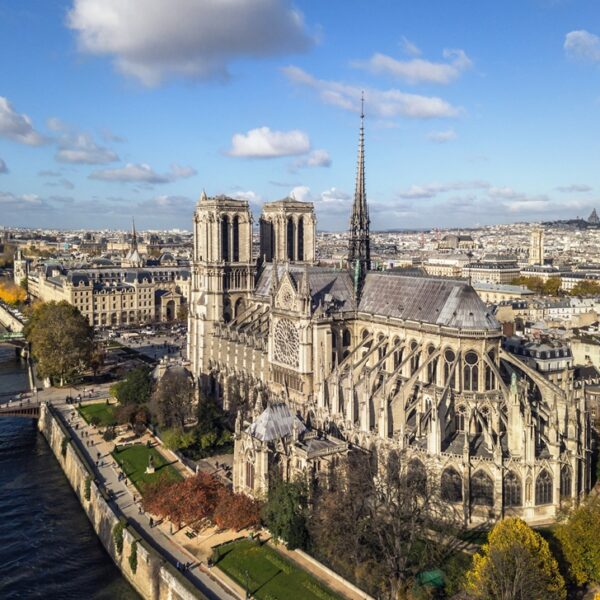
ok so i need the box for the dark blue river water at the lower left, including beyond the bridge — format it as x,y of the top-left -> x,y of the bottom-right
0,345 -> 139,600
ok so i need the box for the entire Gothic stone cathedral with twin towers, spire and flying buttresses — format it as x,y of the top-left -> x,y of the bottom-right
188,110 -> 591,522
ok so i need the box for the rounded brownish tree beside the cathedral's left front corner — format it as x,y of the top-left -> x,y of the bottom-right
149,368 -> 196,431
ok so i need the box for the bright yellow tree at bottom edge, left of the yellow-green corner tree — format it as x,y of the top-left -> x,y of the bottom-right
467,517 -> 567,600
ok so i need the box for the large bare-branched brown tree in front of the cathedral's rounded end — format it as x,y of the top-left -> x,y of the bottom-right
310,450 -> 462,599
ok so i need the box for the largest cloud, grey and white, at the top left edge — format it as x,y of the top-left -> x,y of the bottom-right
67,0 -> 313,86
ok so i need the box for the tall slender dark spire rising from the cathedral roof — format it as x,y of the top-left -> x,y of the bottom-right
348,94 -> 371,295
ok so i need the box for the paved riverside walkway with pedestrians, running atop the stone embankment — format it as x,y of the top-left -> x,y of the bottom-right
52,390 -> 243,600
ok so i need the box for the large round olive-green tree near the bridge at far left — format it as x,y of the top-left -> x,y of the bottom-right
24,301 -> 94,385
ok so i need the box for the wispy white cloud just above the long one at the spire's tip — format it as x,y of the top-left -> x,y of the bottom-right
352,49 -> 473,84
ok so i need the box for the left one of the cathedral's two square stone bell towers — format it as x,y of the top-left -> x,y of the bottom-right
188,192 -> 256,377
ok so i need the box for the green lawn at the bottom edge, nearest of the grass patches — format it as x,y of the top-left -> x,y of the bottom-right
215,540 -> 340,600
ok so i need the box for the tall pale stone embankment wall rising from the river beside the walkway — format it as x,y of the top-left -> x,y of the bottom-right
38,403 -> 206,600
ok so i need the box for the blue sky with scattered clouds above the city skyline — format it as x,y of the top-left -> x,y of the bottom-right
0,0 -> 600,230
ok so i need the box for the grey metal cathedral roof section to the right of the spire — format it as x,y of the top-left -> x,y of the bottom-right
358,271 -> 500,330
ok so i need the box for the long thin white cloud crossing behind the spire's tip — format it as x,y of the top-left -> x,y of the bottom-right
283,66 -> 461,119
